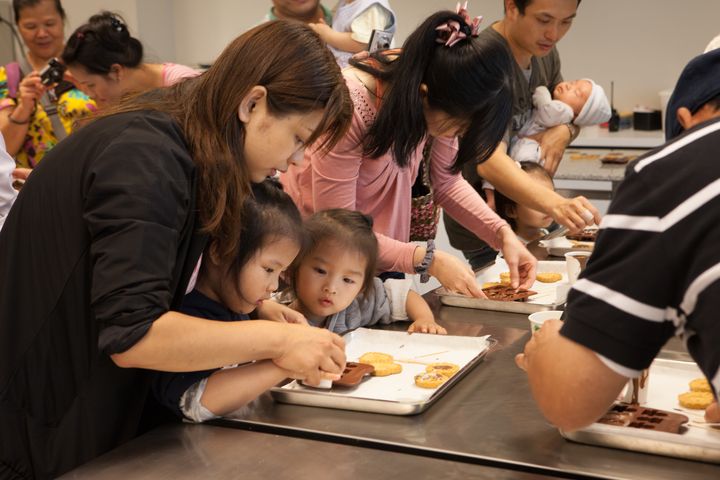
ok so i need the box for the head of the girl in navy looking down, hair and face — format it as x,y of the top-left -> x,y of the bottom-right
196,179 -> 305,313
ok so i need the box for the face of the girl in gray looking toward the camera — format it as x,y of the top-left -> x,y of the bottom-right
295,242 -> 367,318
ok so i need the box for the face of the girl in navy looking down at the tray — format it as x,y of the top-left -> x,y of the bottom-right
214,238 -> 300,313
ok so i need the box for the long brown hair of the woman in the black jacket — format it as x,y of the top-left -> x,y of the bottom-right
102,20 -> 352,258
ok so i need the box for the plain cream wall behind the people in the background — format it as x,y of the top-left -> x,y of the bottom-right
54,0 -> 720,110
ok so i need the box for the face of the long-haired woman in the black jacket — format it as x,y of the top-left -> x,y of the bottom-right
241,97 -> 323,183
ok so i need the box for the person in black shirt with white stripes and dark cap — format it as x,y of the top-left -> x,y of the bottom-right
516,50 -> 720,430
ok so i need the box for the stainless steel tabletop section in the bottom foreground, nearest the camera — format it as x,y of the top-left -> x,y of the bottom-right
60,424 -> 550,480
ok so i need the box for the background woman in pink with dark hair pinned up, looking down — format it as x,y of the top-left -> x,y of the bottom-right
62,12 -> 200,108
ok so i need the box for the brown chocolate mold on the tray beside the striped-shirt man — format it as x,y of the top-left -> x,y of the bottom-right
597,403 -> 689,433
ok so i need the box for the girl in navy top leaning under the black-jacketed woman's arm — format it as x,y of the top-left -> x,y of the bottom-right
153,179 -> 307,422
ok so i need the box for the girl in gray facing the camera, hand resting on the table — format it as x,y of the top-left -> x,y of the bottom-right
280,208 -> 447,334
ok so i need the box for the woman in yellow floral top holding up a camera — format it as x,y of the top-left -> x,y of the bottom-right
0,0 -> 95,168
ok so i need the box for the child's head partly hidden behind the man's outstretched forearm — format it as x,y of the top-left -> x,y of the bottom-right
495,162 -> 555,235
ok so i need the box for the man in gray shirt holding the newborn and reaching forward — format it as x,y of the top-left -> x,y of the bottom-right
444,0 -> 584,268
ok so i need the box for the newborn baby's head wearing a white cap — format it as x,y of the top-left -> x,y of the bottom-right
553,78 -> 611,126
